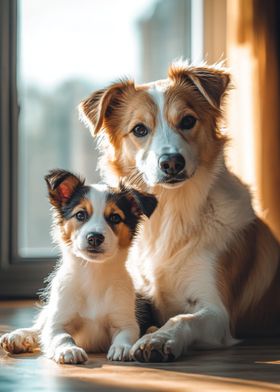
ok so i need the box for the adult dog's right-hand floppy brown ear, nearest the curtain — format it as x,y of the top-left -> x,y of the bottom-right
168,63 -> 230,109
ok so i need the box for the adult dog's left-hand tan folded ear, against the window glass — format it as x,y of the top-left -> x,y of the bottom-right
79,80 -> 135,136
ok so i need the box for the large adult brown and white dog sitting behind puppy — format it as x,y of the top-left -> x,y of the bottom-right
80,63 -> 280,362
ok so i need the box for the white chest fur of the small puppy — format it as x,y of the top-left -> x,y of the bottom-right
46,253 -> 137,352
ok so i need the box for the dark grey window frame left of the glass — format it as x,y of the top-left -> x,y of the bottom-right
0,0 -> 56,299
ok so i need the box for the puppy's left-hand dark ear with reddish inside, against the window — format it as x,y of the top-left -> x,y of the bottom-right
45,169 -> 84,208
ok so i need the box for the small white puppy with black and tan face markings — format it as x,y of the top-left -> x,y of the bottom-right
1,170 -> 157,363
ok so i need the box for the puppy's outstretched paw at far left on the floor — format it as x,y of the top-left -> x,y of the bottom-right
0,329 -> 38,354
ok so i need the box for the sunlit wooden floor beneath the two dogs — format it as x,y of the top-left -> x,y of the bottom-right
0,302 -> 280,392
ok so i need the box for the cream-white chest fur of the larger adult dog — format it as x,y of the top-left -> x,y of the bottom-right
129,171 -> 255,323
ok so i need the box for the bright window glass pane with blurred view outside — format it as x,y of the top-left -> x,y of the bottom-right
18,0 -> 190,257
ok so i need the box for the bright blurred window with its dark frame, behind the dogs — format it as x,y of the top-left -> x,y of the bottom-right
0,0 -> 196,297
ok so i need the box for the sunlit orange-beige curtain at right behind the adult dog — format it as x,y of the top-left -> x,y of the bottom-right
227,0 -> 280,239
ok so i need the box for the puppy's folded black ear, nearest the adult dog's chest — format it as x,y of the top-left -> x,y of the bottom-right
128,189 -> 158,218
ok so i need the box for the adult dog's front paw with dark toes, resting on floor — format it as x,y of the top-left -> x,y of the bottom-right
130,330 -> 182,362
